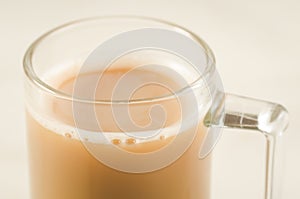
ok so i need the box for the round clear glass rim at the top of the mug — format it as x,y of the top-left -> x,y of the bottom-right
23,15 -> 216,104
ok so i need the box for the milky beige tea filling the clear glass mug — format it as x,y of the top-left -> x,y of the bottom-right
27,67 -> 210,199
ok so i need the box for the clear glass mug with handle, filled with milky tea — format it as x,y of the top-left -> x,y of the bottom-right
24,16 -> 288,199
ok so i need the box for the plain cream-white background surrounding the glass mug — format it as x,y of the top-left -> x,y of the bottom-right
0,0 -> 300,199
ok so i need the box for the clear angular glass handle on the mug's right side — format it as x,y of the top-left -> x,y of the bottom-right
204,93 -> 289,199
